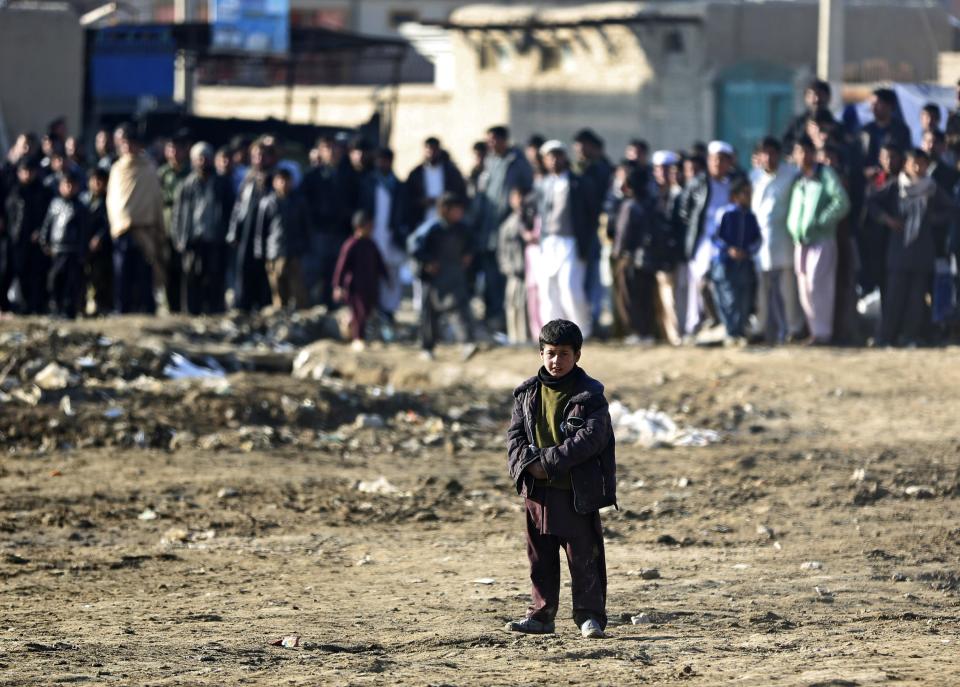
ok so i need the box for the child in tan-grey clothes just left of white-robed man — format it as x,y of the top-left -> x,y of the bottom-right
497,188 -> 530,344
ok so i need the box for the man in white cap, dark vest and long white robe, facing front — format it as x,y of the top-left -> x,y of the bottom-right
536,140 -> 596,337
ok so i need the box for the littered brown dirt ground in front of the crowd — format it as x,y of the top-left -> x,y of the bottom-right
0,320 -> 960,687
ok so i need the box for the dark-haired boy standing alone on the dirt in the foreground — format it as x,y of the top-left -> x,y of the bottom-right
505,320 -> 617,639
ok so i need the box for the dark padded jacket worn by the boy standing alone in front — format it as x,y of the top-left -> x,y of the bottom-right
507,367 -> 617,513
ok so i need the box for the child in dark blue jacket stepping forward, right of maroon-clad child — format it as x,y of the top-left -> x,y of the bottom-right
407,193 -> 476,360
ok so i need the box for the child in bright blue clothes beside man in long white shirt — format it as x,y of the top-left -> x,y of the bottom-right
710,179 -> 763,343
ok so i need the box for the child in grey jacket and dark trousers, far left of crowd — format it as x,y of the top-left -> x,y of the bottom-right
40,171 -> 89,319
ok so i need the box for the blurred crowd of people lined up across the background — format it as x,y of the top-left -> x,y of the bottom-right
0,81 -> 960,356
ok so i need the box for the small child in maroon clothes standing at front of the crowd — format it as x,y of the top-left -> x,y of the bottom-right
333,210 -> 388,351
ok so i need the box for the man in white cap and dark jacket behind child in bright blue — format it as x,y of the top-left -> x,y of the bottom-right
679,141 -> 734,335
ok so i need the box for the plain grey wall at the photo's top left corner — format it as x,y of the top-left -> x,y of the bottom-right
0,7 -> 83,149
